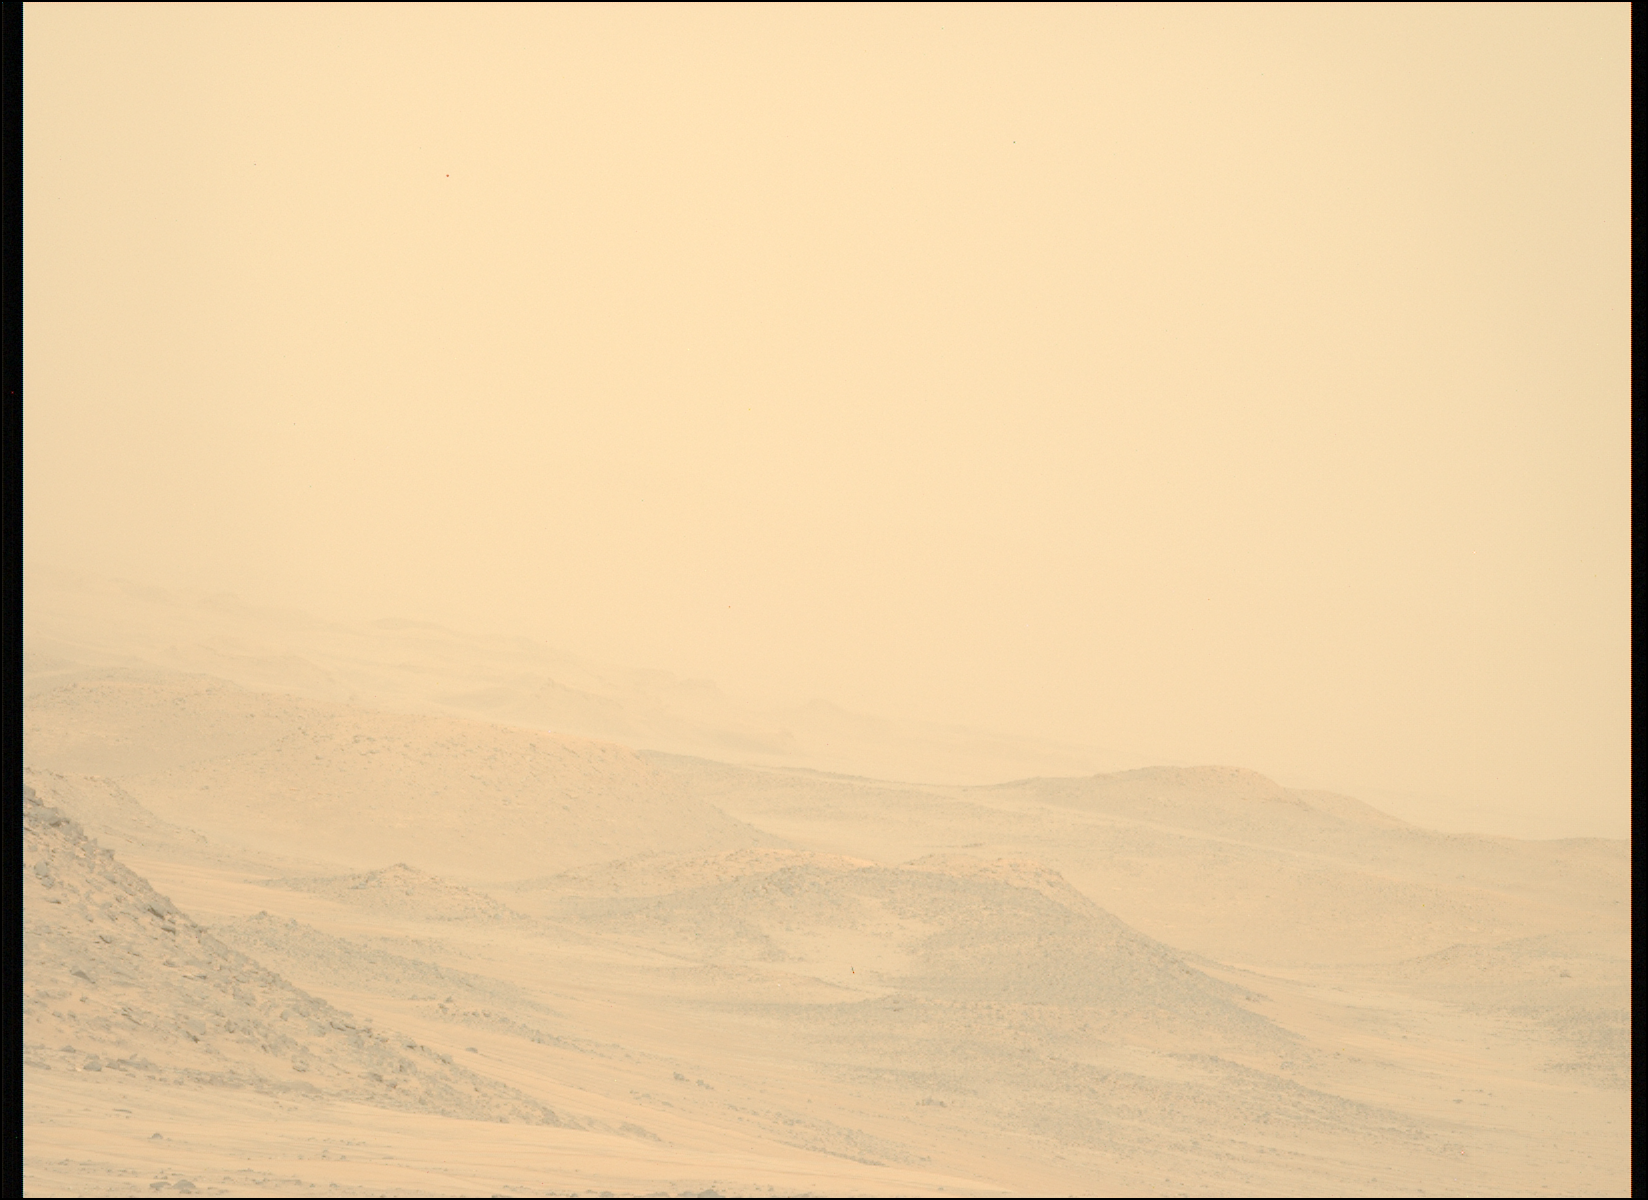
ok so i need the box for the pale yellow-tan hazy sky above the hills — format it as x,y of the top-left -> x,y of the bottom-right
25,3 -> 1630,834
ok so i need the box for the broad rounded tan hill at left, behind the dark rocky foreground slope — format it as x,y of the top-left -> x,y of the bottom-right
25,669 -> 773,879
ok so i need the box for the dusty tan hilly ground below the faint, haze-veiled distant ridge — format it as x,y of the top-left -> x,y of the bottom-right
23,659 -> 1630,1195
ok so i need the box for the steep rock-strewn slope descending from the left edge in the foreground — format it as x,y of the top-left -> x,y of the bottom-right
23,790 -> 562,1124
